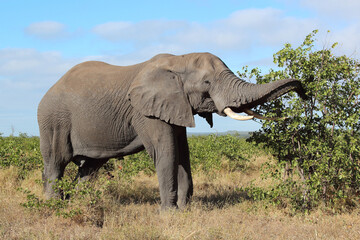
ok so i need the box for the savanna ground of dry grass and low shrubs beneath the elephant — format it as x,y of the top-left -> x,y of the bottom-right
0,134 -> 360,239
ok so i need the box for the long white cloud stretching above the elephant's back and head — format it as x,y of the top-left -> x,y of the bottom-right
93,8 -> 318,53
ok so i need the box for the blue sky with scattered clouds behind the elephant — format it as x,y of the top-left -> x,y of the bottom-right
0,0 -> 360,136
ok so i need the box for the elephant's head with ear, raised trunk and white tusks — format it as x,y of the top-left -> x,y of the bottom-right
128,53 -> 306,127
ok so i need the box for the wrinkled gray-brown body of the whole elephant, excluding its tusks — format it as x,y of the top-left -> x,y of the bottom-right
38,53 -> 305,209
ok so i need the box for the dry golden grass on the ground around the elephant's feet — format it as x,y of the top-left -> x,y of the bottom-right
0,158 -> 360,239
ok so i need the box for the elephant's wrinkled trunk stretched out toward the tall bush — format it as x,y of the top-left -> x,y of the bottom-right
213,70 -> 307,113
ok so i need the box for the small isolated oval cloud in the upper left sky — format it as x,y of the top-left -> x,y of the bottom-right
25,21 -> 69,40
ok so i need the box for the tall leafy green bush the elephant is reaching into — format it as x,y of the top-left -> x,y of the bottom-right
245,31 -> 360,212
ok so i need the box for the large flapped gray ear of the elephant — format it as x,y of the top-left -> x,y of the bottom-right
128,67 -> 195,127
